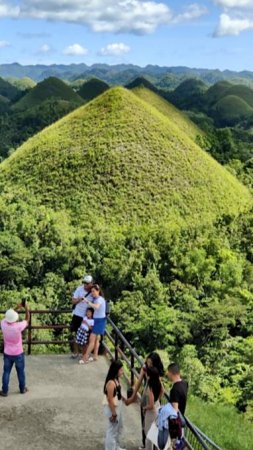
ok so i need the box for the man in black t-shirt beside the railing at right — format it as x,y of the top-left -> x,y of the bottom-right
167,363 -> 188,416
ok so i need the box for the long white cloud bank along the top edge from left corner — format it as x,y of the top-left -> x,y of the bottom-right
0,0 -> 206,35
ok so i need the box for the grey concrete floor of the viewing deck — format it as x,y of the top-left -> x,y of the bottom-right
0,356 -> 141,450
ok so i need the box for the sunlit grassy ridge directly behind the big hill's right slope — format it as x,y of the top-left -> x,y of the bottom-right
132,87 -> 203,141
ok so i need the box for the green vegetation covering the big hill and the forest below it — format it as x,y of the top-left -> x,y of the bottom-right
0,77 -> 253,450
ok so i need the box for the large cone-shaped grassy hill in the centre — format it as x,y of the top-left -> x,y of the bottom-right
0,88 -> 251,224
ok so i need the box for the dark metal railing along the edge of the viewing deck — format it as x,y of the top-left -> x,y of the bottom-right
0,309 -> 221,450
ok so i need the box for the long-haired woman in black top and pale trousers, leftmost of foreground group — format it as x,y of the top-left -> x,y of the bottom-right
103,360 -> 124,450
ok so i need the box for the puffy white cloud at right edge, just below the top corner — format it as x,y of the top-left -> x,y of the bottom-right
214,13 -> 253,37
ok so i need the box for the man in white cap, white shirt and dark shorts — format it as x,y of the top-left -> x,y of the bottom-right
70,275 -> 93,358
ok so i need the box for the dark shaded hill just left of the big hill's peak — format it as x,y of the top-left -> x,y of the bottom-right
13,77 -> 83,110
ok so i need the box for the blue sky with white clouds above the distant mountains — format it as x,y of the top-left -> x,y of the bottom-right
0,0 -> 253,70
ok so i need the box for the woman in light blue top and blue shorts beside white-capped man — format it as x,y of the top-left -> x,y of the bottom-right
79,284 -> 106,364
